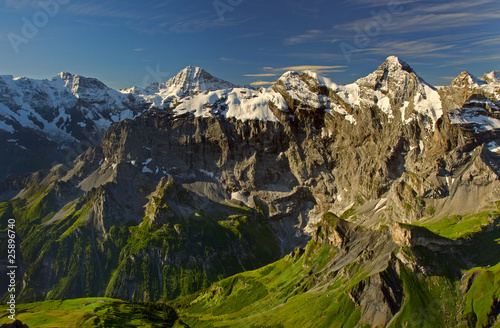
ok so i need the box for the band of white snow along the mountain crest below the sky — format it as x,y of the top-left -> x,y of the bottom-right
0,56 -> 500,136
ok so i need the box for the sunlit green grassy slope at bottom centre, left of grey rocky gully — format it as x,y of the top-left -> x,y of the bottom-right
176,243 -> 368,327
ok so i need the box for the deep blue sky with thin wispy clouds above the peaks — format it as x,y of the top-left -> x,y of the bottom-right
0,0 -> 500,89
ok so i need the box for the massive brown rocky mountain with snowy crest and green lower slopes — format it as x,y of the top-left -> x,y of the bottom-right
0,57 -> 500,327
